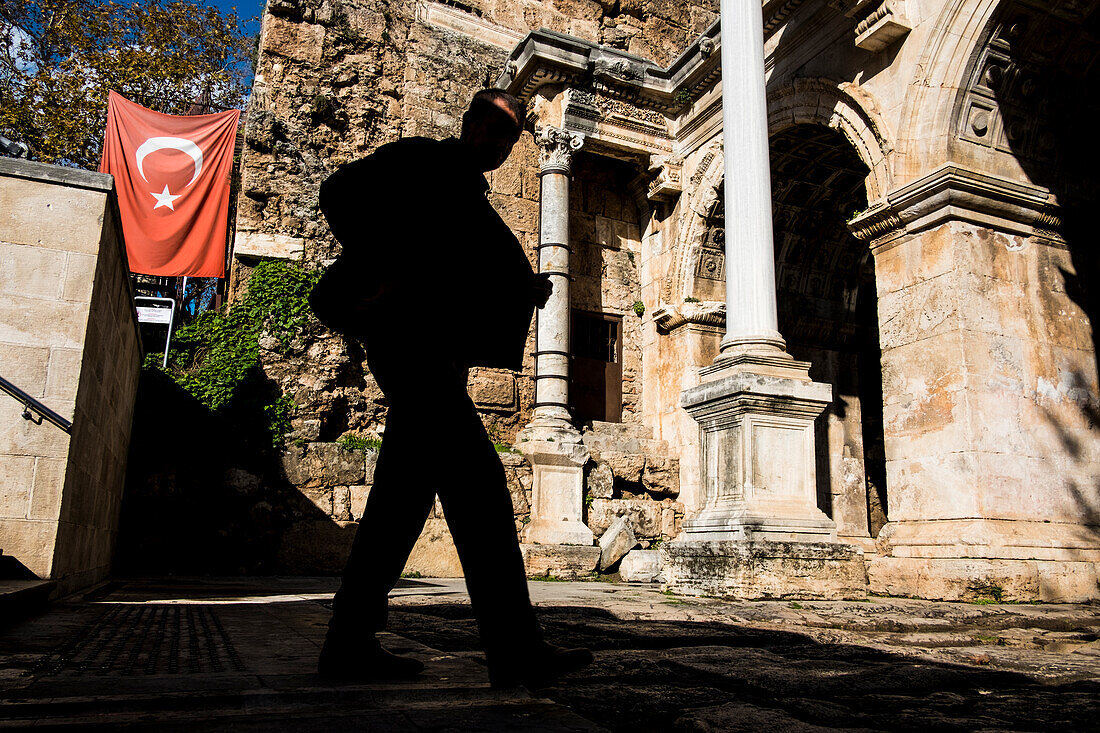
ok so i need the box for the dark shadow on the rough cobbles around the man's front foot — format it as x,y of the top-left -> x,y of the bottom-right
391,604 -> 1100,733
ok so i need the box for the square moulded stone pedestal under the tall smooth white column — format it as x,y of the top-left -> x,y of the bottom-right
666,352 -> 867,598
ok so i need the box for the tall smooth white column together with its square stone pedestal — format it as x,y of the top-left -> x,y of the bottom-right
666,0 -> 866,598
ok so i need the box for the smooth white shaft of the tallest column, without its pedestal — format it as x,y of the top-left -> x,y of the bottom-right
718,0 -> 785,354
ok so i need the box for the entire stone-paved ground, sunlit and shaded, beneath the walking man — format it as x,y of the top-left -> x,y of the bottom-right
0,578 -> 1100,732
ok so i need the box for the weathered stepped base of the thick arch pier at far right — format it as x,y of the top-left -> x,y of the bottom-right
868,512 -> 1100,603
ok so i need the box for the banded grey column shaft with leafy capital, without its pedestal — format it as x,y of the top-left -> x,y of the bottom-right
531,128 -> 584,422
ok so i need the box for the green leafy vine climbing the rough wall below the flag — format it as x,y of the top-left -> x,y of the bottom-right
145,261 -> 320,448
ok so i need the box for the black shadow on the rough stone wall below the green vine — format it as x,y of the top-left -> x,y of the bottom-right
113,369 -> 354,576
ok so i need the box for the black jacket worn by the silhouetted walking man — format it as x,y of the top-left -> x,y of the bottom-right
310,138 -> 535,370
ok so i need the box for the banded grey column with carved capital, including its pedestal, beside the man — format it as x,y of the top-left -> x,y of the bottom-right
519,127 -> 598,548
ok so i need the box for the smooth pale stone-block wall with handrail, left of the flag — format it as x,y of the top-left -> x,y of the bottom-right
0,158 -> 141,593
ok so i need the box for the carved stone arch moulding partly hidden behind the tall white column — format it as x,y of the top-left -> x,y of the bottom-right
662,78 -> 893,305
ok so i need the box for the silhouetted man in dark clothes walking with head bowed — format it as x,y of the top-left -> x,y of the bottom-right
311,89 -> 592,687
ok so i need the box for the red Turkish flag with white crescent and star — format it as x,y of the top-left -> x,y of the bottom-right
99,91 -> 240,277
